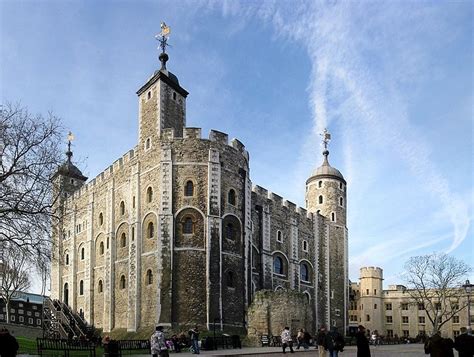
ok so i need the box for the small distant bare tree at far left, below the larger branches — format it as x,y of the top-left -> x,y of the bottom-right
0,244 -> 30,322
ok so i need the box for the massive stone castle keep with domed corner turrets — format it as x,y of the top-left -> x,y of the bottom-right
51,42 -> 348,332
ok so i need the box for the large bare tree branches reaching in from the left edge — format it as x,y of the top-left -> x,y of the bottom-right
0,104 -> 62,255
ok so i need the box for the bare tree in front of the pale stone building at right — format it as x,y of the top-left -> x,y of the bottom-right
405,253 -> 472,333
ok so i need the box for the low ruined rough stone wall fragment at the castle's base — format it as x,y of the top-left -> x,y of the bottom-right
248,290 -> 314,345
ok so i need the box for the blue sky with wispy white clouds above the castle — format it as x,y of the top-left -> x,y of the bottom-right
0,0 -> 474,290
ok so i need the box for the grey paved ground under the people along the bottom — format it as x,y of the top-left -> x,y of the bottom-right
130,344 -> 430,357
